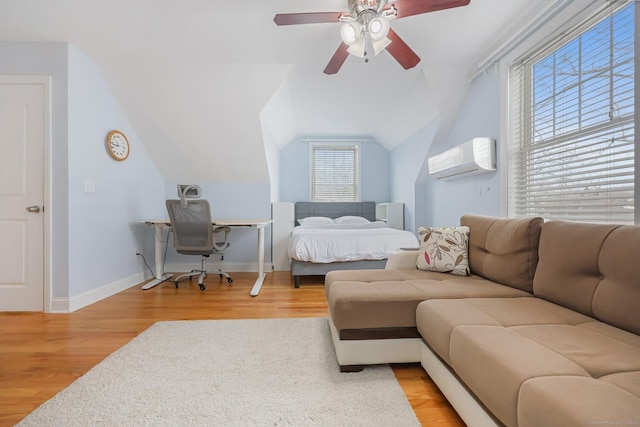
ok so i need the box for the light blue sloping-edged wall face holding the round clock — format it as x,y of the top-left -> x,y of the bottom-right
68,45 -> 164,297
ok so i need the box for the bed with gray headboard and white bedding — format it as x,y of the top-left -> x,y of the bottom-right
288,202 -> 418,288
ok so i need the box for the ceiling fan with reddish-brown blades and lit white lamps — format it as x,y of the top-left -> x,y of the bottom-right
273,0 -> 471,74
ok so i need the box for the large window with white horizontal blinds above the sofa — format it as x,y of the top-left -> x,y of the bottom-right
508,2 -> 635,224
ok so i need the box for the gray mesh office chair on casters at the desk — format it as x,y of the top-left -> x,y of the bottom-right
166,198 -> 233,290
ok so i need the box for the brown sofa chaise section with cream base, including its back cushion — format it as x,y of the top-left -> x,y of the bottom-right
325,215 -> 542,370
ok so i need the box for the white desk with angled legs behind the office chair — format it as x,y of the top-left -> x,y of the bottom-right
142,219 -> 272,297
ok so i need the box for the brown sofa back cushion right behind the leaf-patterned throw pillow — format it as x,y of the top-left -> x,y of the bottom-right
460,215 -> 543,292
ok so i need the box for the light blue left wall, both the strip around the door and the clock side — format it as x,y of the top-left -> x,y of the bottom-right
0,42 -> 164,299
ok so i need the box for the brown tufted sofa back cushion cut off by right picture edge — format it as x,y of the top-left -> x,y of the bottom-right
533,221 -> 640,334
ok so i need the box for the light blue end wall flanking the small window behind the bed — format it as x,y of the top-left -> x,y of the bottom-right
274,138 -> 391,203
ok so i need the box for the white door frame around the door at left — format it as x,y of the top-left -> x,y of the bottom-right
0,74 -> 53,313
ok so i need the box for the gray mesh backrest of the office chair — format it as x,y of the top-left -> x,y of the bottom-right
166,200 -> 214,255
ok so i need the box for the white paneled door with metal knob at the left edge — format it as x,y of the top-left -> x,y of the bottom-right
0,76 -> 48,311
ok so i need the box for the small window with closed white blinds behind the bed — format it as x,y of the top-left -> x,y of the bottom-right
311,143 -> 360,202
